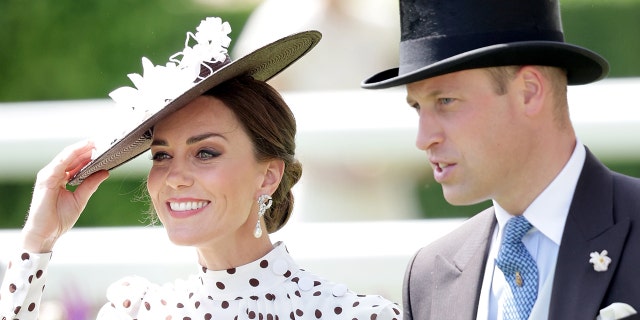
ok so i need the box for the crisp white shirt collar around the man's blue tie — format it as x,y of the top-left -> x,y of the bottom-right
493,141 -> 586,245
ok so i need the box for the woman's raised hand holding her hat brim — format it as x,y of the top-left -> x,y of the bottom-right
22,141 -> 109,253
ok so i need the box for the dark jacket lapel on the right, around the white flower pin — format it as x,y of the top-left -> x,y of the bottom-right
549,150 -> 630,319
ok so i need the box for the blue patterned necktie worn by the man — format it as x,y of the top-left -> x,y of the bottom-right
496,216 -> 538,320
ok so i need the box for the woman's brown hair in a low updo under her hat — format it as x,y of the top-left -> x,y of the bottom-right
205,76 -> 302,233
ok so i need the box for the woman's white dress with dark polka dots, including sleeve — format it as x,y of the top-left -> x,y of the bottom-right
0,243 -> 402,320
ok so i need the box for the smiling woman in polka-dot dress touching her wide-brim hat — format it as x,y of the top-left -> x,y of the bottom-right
0,20 -> 401,319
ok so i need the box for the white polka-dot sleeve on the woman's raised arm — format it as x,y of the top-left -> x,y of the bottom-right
0,251 -> 51,320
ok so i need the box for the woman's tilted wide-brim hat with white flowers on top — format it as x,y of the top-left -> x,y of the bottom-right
68,18 -> 322,186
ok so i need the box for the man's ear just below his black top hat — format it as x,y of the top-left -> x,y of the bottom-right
518,66 -> 549,116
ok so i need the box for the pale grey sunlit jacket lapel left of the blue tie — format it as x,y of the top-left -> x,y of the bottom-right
431,208 -> 496,319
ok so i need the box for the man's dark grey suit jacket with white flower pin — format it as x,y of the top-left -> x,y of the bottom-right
403,150 -> 640,320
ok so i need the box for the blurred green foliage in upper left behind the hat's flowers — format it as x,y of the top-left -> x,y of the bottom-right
0,0 -> 252,101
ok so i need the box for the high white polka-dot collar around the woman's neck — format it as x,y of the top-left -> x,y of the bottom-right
199,242 -> 300,300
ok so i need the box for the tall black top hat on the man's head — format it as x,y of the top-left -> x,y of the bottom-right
361,0 -> 609,89
